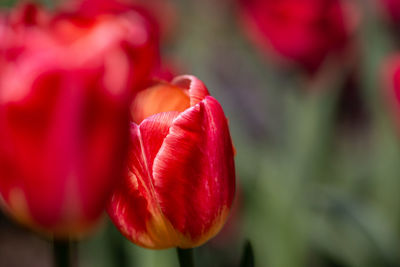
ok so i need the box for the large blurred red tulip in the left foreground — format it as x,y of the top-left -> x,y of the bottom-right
0,2 -> 156,237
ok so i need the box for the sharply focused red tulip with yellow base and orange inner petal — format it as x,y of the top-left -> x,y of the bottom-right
108,76 -> 235,249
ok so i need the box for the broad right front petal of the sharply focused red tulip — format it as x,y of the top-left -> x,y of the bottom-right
153,96 -> 235,248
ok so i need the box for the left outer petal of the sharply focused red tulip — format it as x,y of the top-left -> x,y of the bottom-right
108,112 -> 179,248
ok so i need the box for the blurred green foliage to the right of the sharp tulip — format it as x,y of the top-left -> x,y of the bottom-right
170,1 -> 400,267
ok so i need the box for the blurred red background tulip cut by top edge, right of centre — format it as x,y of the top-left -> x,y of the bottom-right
238,0 -> 357,73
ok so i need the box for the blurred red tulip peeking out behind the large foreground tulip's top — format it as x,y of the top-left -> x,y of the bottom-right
57,0 -> 160,90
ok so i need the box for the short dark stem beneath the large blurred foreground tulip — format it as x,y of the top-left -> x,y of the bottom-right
53,239 -> 77,267
